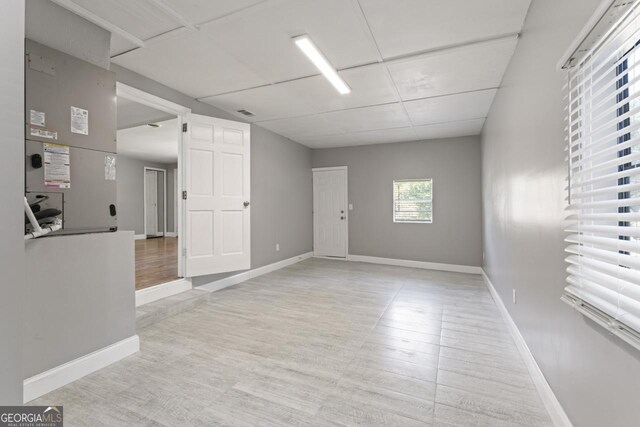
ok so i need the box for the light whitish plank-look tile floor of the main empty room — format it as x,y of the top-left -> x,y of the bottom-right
32,259 -> 552,427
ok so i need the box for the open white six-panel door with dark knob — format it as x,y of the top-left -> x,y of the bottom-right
183,114 -> 251,277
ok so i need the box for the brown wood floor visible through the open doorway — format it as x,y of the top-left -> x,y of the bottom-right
135,237 -> 178,289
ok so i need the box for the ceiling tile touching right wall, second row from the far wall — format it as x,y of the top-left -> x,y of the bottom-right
404,89 -> 498,125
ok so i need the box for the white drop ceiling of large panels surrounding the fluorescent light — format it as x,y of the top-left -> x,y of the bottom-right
54,0 -> 530,148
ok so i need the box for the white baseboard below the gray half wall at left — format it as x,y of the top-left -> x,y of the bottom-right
23,335 -> 140,403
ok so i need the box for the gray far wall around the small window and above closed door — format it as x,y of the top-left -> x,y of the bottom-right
312,137 -> 482,266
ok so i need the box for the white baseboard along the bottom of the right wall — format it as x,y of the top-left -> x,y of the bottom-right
482,270 -> 572,427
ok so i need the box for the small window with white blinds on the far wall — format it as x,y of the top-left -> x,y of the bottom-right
393,179 -> 433,224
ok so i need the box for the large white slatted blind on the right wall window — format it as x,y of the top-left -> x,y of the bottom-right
563,3 -> 640,348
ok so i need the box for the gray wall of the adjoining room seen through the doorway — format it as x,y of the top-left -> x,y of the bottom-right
116,155 -> 176,234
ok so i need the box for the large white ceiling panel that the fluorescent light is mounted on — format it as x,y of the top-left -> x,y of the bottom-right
115,0 -> 377,98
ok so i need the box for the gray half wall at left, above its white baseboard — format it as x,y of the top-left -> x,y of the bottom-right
23,231 -> 135,378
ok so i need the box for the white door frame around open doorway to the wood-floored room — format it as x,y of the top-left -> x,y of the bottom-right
116,82 -> 191,280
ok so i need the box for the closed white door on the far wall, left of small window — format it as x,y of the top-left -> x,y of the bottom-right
313,168 -> 347,258
